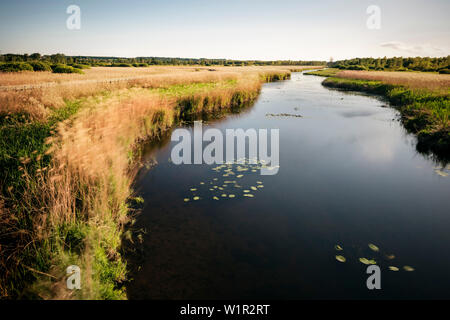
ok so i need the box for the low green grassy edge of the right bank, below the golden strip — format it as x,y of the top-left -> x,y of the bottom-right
323,74 -> 450,159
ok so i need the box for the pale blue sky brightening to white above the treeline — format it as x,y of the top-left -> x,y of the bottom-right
0,0 -> 450,60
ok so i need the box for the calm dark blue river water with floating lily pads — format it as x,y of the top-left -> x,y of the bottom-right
127,73 -> 450,299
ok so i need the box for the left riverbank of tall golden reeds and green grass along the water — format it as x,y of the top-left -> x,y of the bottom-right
0,68 -> 289,299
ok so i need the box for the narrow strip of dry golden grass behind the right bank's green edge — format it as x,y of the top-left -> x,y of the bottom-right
337,70 -> 450,94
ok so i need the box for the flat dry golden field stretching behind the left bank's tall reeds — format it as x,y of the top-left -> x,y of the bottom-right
0,67 -> 308,120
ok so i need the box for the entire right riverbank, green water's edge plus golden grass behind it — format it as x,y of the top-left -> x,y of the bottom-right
317,70 -> 450,160
